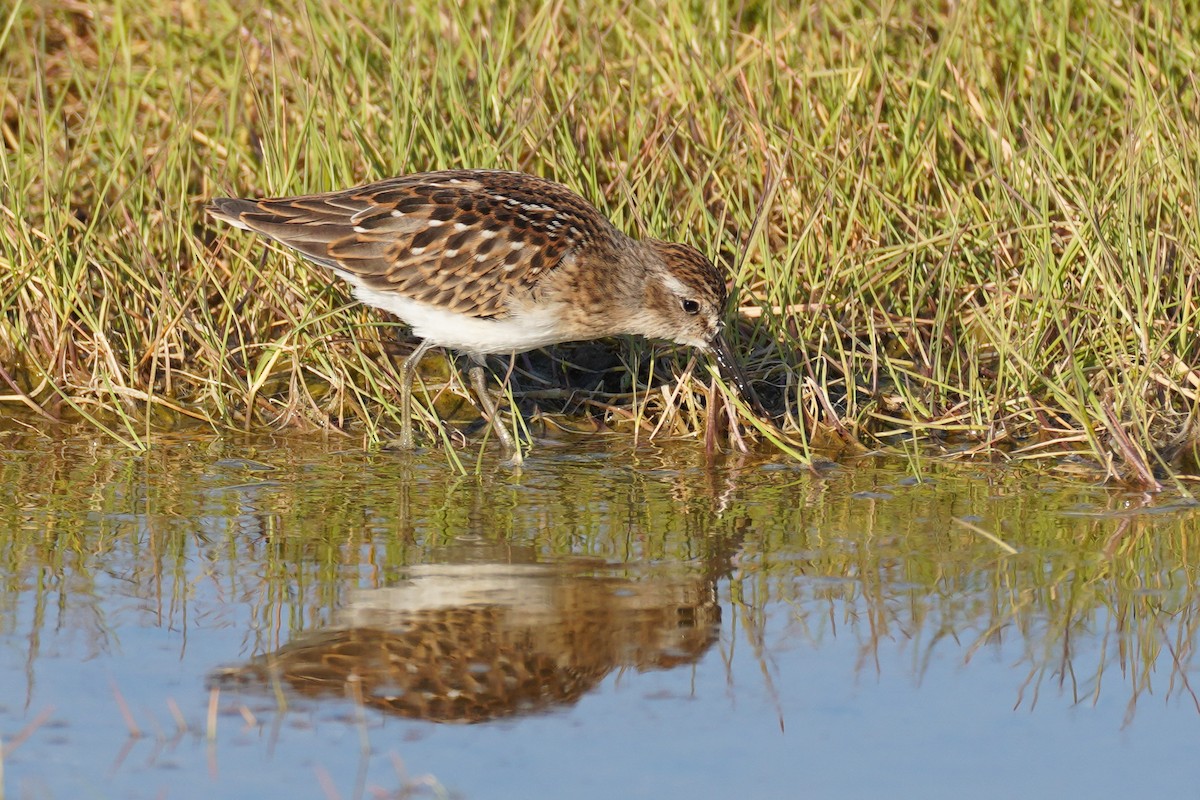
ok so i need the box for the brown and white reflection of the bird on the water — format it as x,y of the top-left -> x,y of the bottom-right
211,561 -> 720,722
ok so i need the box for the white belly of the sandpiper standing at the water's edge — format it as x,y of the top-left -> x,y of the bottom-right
342,281 -> 575,355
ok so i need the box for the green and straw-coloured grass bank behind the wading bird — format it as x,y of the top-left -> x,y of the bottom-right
0,0 -> 1200,486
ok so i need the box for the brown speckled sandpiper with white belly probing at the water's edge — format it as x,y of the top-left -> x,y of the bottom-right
208,169 -> 755,459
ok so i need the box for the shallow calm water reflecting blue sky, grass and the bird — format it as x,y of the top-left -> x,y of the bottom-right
0,433 -> 1200,798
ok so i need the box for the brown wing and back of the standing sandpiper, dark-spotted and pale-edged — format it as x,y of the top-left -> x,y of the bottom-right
211,170 -> 619,318
